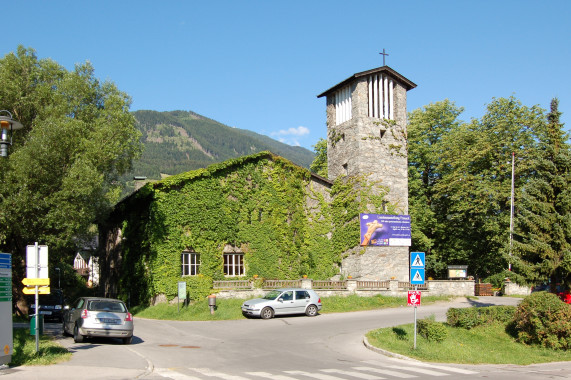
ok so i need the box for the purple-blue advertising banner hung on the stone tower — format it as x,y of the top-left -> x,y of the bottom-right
359,214 -> 411,247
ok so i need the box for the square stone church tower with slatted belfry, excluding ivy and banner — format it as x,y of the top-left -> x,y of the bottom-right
318,66 -> 416,281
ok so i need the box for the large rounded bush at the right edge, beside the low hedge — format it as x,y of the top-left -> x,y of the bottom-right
512,292 -> 571,350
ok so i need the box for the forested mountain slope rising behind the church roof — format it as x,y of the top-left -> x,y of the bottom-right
124,110 -> 314,193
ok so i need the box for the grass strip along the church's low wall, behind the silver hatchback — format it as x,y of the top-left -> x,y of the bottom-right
130,295 -> 452,321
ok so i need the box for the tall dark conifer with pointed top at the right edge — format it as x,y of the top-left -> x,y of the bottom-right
514,99 -> 571,287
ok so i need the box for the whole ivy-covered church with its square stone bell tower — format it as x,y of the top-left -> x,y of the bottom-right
99,66 -> 416,303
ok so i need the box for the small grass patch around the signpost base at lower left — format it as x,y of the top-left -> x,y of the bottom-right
9,329 -> 71,367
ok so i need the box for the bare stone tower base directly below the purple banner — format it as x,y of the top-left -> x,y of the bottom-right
341,247 -> 410,282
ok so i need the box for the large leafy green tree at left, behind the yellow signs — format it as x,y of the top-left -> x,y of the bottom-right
0,46 -> 141,270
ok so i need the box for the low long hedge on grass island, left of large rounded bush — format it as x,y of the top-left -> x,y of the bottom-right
446,306 -> 516,330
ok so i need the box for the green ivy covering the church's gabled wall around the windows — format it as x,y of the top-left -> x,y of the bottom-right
101,152 -> 392,304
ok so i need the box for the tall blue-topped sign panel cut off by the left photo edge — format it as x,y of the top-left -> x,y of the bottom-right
0,253 -> 14,365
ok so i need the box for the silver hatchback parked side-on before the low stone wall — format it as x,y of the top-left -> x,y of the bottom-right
242,288 -> 321,319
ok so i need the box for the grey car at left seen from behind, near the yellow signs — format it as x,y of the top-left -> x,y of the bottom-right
63,297 -> 133,344
